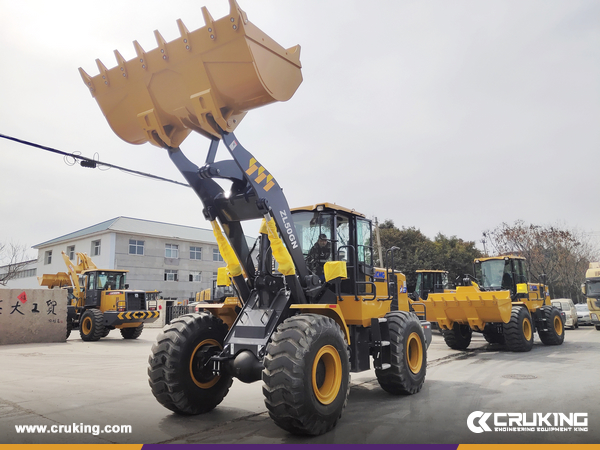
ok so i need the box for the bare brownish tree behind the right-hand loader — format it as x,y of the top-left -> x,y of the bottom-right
483,220 -> 598,302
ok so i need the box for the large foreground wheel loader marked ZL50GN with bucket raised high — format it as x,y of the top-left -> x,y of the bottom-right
81,0 -> 431,435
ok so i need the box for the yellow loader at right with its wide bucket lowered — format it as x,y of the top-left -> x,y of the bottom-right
422,256 -> 565,352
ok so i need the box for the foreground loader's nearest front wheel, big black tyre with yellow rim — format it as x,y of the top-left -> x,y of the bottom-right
262,314 -> 350,436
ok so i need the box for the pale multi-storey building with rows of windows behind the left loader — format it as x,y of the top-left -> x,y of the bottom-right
1,217 -> 248,300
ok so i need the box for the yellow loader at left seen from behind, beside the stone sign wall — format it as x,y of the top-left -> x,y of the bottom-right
38,252 -> 160,341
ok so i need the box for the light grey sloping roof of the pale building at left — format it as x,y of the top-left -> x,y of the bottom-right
33,217 -> 229,249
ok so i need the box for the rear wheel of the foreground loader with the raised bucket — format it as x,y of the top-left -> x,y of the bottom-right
375,311 -> 427,395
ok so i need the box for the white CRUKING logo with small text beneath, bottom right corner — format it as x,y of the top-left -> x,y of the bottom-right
467,411 -> 588,433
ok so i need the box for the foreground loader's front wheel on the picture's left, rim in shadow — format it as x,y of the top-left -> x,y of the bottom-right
148,313 -> 233,415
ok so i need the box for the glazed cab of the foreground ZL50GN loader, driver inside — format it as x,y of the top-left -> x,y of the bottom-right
292,203 -> 374,295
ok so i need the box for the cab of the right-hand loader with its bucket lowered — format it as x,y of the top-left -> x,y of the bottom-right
474,256 -> 528,299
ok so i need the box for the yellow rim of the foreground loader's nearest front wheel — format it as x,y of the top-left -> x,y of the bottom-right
312,345 -> 342,405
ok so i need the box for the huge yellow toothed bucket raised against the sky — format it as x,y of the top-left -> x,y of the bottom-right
79,0 -> 302,147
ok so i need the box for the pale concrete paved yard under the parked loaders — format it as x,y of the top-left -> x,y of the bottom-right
0,327 -> 600,444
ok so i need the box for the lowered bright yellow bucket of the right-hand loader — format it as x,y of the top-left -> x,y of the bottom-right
422,286 -> 512,331
